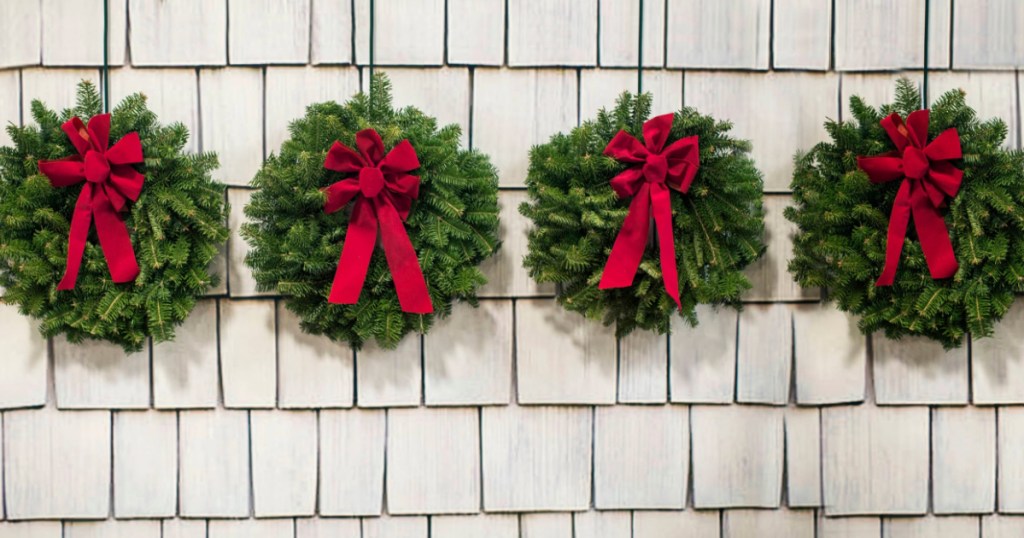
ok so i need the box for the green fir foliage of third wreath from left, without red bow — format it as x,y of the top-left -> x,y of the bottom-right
519,93 -> 765,337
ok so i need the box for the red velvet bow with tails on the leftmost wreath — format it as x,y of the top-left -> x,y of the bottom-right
39,114 -> 145,290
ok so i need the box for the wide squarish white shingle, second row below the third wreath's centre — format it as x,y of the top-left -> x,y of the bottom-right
594,406 -> 690,509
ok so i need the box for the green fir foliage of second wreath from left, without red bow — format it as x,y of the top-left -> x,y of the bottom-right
242,74 -> 500,348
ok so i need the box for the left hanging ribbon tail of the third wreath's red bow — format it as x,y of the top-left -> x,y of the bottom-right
598,183 -> 650,290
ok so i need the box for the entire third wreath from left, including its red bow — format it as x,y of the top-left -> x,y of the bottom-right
519,93 -> 765,336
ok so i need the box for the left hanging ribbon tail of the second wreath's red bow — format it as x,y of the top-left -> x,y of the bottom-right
328,199 -> 377,304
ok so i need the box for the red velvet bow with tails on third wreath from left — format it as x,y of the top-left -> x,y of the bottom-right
598,114 -> 700,308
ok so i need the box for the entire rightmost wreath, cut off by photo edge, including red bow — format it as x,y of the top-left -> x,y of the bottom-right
785,79 -> 1024,348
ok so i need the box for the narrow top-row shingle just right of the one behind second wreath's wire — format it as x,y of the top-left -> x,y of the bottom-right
447,0 -> 505,66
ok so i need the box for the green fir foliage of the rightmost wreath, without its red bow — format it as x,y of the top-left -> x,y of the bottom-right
785,79 -> 1024,348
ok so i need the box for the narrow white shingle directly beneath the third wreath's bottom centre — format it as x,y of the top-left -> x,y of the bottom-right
618,331 -> 669,404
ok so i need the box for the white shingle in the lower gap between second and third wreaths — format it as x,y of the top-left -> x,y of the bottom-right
477,189 -> 555,297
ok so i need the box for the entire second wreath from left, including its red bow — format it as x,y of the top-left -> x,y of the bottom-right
242,75 -> 499,347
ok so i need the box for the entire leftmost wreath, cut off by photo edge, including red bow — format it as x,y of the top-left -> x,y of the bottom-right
0,82 -> 227,351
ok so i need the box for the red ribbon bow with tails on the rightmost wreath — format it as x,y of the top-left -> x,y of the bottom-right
857,110 -> 964,286
